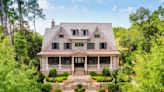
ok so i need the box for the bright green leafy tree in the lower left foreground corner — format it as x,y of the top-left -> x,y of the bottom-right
0,37 -> 39,92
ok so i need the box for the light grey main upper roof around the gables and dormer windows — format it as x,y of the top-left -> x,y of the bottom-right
42,23 -> 116,50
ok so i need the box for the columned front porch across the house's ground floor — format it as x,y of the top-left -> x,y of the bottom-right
40,55 -> 119,75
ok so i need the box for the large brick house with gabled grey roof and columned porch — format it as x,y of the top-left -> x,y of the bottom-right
38,21 -> 120,74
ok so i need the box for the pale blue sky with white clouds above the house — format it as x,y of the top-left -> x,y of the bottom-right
31,0 -> 164,35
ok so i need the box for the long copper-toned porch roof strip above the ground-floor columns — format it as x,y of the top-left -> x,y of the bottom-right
37,51 -> 120,56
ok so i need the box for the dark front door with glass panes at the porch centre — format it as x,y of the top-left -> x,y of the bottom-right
74,57 -> 85,68
